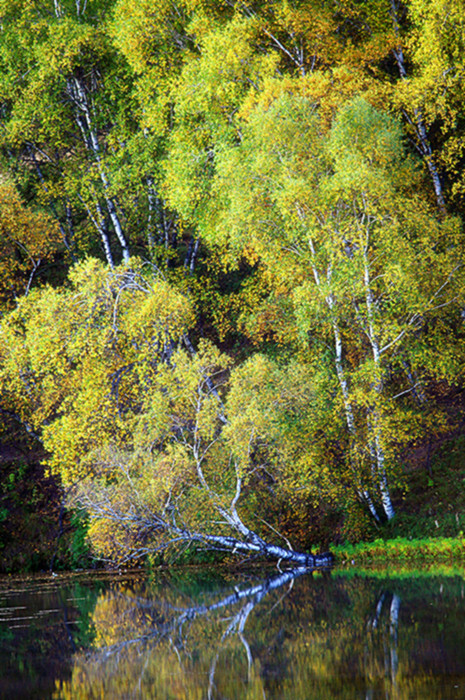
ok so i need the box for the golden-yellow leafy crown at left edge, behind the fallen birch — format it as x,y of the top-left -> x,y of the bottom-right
0,260 -> 191,481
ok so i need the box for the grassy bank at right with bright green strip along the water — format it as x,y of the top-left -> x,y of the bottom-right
322,432 -> 465,573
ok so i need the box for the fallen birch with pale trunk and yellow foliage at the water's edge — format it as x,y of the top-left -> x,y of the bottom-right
61,328 -> 332,568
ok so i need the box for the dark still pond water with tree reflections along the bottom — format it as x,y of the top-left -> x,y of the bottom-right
0,569 -> 465,700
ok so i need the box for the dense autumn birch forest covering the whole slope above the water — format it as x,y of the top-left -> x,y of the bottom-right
0,0 -> 465,570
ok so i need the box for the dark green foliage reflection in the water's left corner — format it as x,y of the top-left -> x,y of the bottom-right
0,576 -> 105,698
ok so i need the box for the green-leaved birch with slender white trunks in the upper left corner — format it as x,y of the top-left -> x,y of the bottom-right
0,0 -> 135,265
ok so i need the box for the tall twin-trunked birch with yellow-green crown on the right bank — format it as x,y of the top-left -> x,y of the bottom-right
201,91 -> 461,519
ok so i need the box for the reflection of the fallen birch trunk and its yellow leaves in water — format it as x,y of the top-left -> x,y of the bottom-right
60,568 -> 308,698
